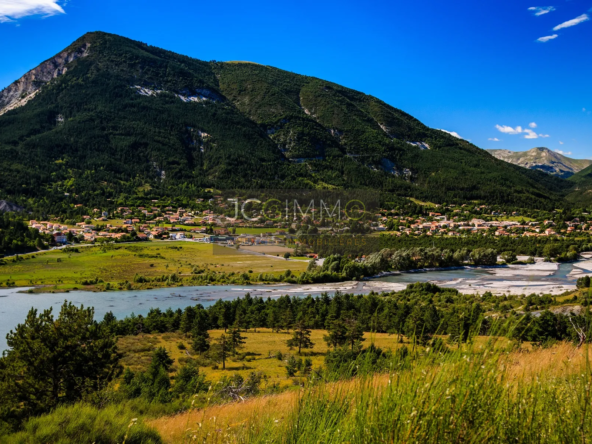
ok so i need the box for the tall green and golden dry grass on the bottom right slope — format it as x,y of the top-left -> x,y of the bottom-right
150,344 -> 592,444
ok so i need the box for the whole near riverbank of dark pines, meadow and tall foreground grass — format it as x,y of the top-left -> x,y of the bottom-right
0,284 -> 592,443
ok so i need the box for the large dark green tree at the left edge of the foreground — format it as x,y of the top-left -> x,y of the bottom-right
0,302 -> 120,424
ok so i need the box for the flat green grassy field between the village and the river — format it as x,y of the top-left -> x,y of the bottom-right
0,241 -> 308,290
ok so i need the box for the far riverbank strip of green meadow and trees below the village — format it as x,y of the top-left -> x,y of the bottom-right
5,237 -> 592,292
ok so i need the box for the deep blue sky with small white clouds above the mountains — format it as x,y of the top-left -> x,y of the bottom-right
0,0 -> 592,158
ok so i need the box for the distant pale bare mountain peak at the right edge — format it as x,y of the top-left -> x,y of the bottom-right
487,148 -> 592,179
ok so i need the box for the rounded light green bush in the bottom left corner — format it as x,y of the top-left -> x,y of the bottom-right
2,404 -> 162,444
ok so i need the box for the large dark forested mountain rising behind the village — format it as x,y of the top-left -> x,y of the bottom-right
0,32 -> 572,212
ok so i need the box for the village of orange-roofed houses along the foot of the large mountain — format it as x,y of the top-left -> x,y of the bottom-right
29,197 -> 592,247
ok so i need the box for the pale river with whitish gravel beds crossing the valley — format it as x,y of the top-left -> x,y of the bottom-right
0,257 -> 592,350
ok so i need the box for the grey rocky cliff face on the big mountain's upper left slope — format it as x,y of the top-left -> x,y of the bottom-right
0,43 -> 90,115
